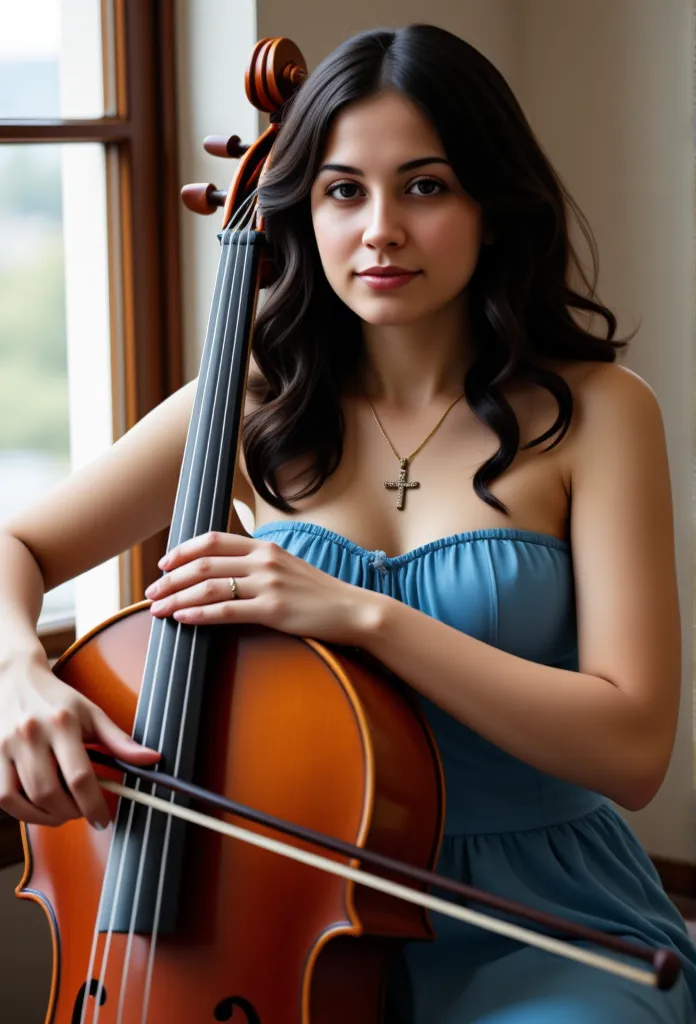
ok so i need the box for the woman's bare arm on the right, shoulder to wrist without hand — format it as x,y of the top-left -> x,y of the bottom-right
356,365 -> 681,810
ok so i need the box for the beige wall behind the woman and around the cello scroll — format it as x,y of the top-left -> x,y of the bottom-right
0,0 -> 696,1024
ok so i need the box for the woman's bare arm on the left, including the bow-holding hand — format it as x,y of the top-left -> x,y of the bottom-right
0,381 -> 207,825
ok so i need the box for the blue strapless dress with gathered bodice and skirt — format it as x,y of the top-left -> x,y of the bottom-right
254,521 -> 696,1024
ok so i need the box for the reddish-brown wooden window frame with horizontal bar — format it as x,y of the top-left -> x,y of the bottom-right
0,0 -> 183,868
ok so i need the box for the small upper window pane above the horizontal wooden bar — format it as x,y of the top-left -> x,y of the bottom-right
0,0 -> 115,119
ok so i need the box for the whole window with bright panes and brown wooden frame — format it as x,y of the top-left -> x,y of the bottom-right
0,0 -> 182,866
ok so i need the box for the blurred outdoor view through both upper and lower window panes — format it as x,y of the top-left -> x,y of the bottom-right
0,3 -> 74,621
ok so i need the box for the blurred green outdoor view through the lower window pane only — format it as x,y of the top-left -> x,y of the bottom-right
0,145 -> 72,615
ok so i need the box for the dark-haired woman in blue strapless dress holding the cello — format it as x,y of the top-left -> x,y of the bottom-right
0,26 -> 696,1024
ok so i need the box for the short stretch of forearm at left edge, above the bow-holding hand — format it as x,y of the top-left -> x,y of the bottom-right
0,531 -> 44,667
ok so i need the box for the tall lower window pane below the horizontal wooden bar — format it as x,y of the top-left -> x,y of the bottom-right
0,143 -> 118,624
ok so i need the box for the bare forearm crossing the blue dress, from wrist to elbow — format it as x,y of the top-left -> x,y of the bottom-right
356,595 -> 659,809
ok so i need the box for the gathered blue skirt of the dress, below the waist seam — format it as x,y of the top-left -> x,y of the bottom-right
387,804 -> 696,1024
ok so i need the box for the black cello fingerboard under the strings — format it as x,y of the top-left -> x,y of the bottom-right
98,229 -> 265,934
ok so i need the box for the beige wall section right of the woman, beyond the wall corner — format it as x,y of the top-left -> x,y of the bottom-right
519,0 -> 696,862
